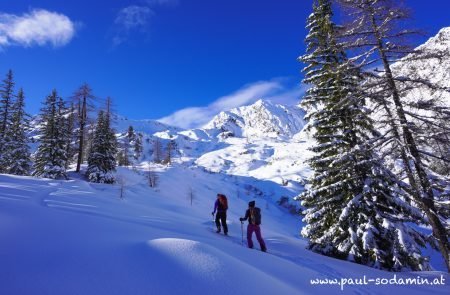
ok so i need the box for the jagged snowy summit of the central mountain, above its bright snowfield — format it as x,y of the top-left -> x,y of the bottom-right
203,99 -> 304,138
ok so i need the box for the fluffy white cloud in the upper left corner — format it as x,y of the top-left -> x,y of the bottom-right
0,9 -> 76,47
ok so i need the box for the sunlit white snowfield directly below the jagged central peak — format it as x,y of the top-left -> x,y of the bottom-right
195,132 -> 311,187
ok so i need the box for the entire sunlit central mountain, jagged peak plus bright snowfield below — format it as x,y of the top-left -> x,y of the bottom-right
188,100 -> 311,187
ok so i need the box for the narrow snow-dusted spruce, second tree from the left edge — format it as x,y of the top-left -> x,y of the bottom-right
5,89 -> 31,175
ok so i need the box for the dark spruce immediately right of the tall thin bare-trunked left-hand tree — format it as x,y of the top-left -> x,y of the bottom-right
86,111 -> 116,183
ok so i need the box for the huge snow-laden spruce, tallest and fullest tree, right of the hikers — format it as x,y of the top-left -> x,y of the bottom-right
300,0 -> 428,271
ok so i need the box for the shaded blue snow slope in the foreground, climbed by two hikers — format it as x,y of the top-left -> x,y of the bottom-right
0,171 -> 450,295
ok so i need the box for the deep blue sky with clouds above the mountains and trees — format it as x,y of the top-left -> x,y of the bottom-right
0,0 -> 450,127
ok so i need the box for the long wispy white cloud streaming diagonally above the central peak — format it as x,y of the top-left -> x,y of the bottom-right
158,79 -> 304,129
